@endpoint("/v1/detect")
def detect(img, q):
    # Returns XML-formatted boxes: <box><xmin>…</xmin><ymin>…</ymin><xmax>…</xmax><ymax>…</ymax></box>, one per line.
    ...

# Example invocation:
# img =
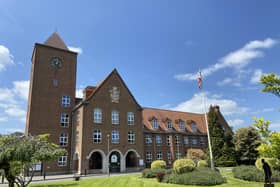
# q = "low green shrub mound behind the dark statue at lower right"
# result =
<box><xmin>232</xmin><ymin>166</ymin><xmax>280</xmax><ymax>182</ymax></box>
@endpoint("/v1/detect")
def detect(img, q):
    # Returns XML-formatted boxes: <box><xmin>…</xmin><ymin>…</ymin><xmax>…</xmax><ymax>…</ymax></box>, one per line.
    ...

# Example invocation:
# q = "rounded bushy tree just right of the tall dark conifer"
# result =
<box><xmin>234</xmin><ymin>127</ymin><xmax>261</xmax><ymax>165</ymax></box>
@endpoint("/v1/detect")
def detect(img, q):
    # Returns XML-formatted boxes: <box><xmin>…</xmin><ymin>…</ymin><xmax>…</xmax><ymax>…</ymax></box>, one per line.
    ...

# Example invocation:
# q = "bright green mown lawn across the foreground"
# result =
<box><xmin>31</xmin><ymin>168</ymin><xmax>280</xmax><ymax>187</ymax></box>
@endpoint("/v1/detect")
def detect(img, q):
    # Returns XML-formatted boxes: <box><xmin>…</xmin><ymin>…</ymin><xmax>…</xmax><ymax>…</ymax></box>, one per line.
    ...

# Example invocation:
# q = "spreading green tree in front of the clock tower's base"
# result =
<box><xmin>0</xmin><ymin>135</ymin><xmax>65</xmax><ymax>187</ymax></box>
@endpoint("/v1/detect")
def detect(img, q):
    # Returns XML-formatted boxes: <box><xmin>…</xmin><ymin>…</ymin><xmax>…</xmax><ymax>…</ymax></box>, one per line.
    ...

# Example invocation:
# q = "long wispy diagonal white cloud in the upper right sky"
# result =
<box><xmin>175</xmin><ymin>38</ymin><xmax>278</xmax><ymax>80</ymax></box>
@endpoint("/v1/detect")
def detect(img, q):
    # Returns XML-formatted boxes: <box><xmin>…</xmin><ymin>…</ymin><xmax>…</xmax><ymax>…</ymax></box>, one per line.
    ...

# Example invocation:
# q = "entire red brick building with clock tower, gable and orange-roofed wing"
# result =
<box><xmin>25</xmin><ymin>33</ymin><xmax>229</xmax><ymax>173</ymax></box>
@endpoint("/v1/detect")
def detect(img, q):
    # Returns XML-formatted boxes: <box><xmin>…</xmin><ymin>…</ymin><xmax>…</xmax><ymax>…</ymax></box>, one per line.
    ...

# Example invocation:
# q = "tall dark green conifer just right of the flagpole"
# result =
<box><xmin>207</xmin><ymin>107</ymin><xmax>236</xmax><ymax>166</ymax></box>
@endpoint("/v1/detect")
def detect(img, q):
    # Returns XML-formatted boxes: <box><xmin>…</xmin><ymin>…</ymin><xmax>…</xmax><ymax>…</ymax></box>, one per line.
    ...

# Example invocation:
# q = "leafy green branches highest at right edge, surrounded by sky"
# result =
<box><xmin>260</xmin><ymin>73</ymin><xmax>280</xmax><ymax>97</ymax></box>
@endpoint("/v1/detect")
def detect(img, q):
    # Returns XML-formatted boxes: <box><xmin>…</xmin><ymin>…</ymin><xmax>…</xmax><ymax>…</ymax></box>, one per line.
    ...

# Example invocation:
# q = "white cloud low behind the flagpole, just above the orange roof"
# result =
<box><xmin>171</xmin><ymin>93</ymin><xmax>248</xmax><ymax>115</ymax></box>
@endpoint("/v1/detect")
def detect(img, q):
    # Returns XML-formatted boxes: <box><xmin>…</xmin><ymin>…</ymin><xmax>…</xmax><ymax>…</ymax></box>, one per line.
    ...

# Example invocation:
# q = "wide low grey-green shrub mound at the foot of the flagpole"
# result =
<box><xmin>164</xmin><ymin>168</ymin><xmax>226</xmax><ymax>185</ymax></box>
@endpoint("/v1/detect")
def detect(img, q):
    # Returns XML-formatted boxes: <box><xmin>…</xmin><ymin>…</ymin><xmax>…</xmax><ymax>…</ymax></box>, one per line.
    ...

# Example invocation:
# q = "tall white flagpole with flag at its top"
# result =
<box><xmin>198</xmin><ymin>70</ymin><xmax>215</xmax><ymax>170</ymax></box>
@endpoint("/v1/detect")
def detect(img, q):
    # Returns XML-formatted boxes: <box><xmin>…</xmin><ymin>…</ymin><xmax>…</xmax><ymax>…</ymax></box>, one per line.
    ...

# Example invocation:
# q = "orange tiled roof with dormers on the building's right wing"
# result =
<box><xmin>142</xmin><ymin>108</ymin><xmax>206</xmax><ymax>134</ymax></box>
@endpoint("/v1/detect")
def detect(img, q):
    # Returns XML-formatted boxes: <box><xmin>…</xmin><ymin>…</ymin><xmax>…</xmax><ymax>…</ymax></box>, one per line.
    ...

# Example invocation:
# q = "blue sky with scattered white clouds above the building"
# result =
<box><xmin>0</xmin><ymin>0</ymin><xmax>280</xmax><ymax>134</ymax></box>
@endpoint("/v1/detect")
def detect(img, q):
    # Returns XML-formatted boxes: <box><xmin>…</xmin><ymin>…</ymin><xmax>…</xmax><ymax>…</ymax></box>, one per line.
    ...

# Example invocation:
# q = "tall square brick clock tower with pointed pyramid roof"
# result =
<box><xmin>25</xmin><ymin>32</ymin><xmax>77</xmax><ymax>173</ymax></box>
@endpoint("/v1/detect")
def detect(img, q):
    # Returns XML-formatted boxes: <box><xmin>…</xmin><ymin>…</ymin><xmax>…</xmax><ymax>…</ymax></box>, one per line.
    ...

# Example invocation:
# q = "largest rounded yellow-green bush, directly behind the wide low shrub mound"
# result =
<box><xmin>173</xmin><ymin>159</ymin><xmax>195</xmax><ymax>174</ymax></box>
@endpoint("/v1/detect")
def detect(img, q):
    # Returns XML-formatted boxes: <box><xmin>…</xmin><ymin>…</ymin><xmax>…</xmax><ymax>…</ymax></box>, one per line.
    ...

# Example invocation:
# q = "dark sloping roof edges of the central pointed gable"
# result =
<box><xmin>84</xmin><ymin>69</ymin><xmax>142</xmax><ymax>108</ymax></box>
